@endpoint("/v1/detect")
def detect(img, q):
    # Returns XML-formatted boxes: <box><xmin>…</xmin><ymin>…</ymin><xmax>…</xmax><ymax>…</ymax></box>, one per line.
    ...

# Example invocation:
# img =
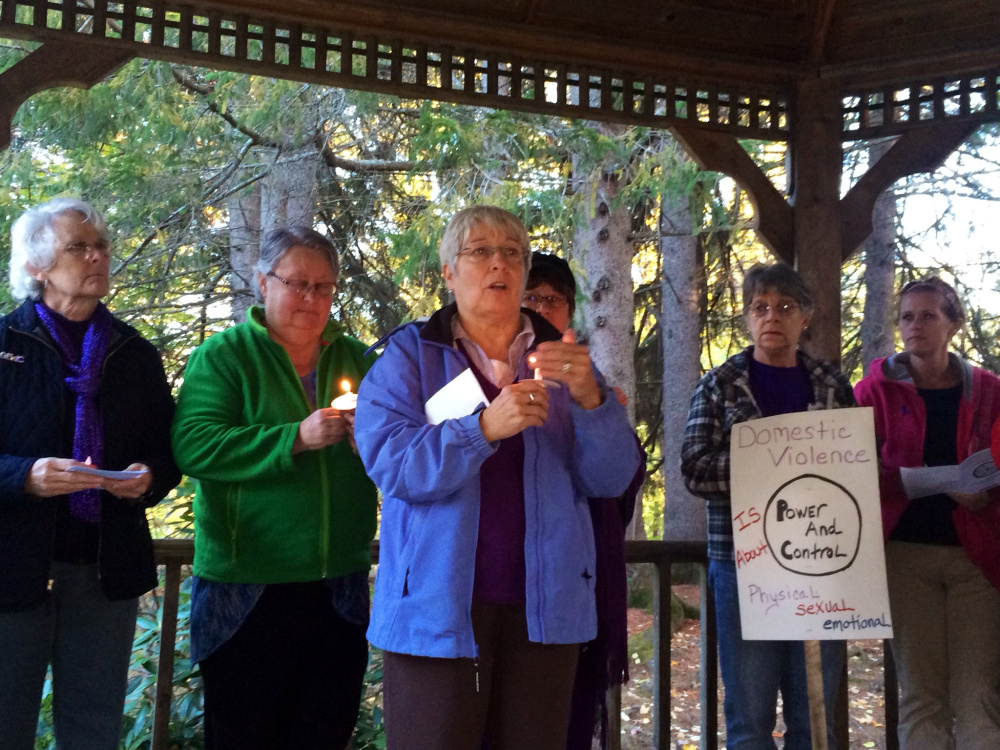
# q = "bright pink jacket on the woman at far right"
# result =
<box><xmin>854</xmin><ymin>352</ymin><xmax>1000</xmax><ymax>589</ymax></box>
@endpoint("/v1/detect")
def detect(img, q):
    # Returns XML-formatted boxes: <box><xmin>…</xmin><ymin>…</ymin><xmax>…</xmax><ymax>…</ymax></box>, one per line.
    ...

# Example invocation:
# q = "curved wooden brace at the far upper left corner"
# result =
<box><xmin>0</xmin><ymin>39</ymin><xmax>134</xmax><ymax>149</ymax></box>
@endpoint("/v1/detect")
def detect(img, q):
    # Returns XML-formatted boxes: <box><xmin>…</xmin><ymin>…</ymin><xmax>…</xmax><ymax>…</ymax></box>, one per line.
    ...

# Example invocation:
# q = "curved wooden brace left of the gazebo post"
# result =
<box><xmin>670</xmin><ymin>125</ymin><xmax>795</xmax><ymax>264</ymax></box>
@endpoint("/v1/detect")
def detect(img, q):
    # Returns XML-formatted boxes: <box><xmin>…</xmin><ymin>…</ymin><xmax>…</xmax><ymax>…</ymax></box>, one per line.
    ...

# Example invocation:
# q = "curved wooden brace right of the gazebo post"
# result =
<box><xmin>840</xmin><ymin>122</ymin><xmax>976</xmax><ymax>260</ymax></box>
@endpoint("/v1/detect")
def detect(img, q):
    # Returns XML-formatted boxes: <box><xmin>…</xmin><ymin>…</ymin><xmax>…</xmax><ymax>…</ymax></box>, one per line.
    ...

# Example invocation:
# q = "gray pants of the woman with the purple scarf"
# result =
<box><xmin>0</xmin><ymin>563</ymin><xmax>138</xmax><ymax>750</ymax></box>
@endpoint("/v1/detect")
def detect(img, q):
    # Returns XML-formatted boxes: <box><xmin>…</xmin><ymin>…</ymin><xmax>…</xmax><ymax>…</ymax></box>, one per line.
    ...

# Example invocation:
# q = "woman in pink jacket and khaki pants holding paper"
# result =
<box><xmin>855</xmin><ymin>277</ymin><xmax>1000</xmax><ymax>750</ymax></box>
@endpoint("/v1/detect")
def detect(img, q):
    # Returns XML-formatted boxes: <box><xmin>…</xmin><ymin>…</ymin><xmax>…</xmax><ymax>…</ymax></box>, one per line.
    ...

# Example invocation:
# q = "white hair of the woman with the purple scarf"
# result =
<box><xmin>10</xmin><ymin>198</ymin><xmax>111</xmax><ymax>302</ymax></box>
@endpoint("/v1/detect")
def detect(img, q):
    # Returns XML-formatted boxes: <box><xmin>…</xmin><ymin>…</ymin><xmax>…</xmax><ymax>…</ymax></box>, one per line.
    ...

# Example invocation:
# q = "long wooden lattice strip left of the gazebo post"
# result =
<box><xmin>0</xmin><ymin>0</ymin><xmax>789</xmax><ymax>140</ymax></box>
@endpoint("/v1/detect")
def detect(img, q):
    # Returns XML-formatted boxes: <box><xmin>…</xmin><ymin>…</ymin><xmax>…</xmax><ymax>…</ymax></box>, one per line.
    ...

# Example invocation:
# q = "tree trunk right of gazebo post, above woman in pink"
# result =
<box><xmin>861</xmin><ymin>140</ymin><xmax>897</xmax><ymax>375</ymax></box>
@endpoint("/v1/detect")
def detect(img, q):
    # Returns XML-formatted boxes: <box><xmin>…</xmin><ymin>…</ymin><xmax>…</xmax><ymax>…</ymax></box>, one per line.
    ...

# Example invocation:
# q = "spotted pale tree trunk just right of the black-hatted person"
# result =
<box><xmin>574</xmin><ymin>124</ymin><xmax>645</xmax><ymax>538</ymax></box>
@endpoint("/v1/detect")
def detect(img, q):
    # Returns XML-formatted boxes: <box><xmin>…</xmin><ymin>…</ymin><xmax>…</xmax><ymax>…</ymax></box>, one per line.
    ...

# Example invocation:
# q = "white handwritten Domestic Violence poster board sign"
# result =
<box><xmin>730</xmin><ymin>407</ymin><xmax>892</xmax><ymax>641</ymax></box>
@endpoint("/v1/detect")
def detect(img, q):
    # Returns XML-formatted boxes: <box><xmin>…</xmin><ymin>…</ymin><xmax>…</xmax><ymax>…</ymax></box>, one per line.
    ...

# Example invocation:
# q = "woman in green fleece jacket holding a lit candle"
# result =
<box><xmin>173</xmin><ymin>227</ymin><xmax>376</xmax><ymax>750</ymax></box>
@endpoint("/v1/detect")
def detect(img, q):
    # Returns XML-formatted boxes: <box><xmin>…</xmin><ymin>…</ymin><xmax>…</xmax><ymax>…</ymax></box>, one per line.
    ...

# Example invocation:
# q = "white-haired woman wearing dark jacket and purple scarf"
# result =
<box><xmin>0</xmin><ymin>198</ymin><xmax>180</xmax><ymax>750</ymax></box>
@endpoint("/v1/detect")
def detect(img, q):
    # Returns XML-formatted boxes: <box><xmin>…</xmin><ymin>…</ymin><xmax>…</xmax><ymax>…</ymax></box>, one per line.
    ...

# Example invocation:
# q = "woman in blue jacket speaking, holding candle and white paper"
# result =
<box><xmin>355</xmin><ymin>206</ymin><xmax>639</xmax><ymax>750</ymax></box>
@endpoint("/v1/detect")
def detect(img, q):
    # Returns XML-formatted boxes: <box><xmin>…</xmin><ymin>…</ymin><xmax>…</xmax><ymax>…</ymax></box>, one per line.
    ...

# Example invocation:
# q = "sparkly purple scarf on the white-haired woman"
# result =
<box><xmin>35</xmin><ymin>302</ymin><xmax>111</xmax><ymax>524</ymax></box>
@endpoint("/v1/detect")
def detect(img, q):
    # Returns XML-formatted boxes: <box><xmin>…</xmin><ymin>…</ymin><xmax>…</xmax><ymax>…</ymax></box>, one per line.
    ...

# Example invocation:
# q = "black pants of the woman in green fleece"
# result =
<box><xmin>201</xmin><ymin>581</ymin><xmax>368</xmax><ymax>750</ymax></box>
